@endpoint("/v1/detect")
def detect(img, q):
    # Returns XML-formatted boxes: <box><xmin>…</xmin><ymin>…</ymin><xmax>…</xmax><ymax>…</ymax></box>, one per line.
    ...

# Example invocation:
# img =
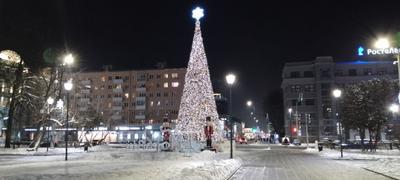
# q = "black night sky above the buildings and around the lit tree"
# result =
<box><xmin>0</xmin><ymin>0</ymin><xmax>400</xmax><ymax>129</ymax></box>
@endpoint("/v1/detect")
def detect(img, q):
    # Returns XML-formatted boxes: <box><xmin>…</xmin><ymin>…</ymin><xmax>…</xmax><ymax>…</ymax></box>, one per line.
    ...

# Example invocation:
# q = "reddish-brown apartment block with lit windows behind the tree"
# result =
<box><xmin>70</xmin><ymin>68</ymin><xmax>186</xmax><ymax>128</ymax></box>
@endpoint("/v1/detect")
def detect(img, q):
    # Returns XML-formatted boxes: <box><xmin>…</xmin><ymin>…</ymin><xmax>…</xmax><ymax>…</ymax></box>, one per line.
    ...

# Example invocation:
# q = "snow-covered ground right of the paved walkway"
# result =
<box><xmin>304</xmin><ymin>148</ymin><xmax>400</xmax><ymax>179</ymax></box>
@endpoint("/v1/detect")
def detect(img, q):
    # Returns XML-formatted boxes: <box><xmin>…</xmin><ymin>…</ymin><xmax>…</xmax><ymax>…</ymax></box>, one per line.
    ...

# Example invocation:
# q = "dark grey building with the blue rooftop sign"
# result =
<box><xmin>281</xmin><ymin>57</ymin><xmax>398</xmax><ymax>142</ymax></box>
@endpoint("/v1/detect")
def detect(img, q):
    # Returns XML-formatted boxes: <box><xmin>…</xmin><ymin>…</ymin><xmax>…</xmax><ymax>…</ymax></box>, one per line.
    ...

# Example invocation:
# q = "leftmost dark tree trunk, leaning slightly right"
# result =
<box><xmin>4</xmin><ymin>60</ymin><xmax>24</xmax><ymax>148</ymax></box>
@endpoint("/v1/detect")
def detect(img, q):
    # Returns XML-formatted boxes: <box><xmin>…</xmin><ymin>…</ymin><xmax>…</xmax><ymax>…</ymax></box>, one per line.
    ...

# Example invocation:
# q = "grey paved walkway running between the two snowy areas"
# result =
<box><xmin>231</xmin><ymin>145</ymin><xmax>388</xmax><ymax>180</ymax></box>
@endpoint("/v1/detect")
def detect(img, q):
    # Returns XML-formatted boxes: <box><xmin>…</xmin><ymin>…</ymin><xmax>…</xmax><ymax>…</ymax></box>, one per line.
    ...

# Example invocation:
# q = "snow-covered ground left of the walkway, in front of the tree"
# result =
<box><xmin>0</xmin><ymin>145</ymin><xmax>241</xmax><ymax>180</ymax></box>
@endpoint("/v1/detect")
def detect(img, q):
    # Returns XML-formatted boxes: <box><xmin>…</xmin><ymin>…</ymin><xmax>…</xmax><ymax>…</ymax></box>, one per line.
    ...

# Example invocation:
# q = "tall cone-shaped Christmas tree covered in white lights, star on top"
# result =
<box><xmin>176</xmin><ymin>8</ymin><xmax>222</xmax><ymax>140</ymax></box>
